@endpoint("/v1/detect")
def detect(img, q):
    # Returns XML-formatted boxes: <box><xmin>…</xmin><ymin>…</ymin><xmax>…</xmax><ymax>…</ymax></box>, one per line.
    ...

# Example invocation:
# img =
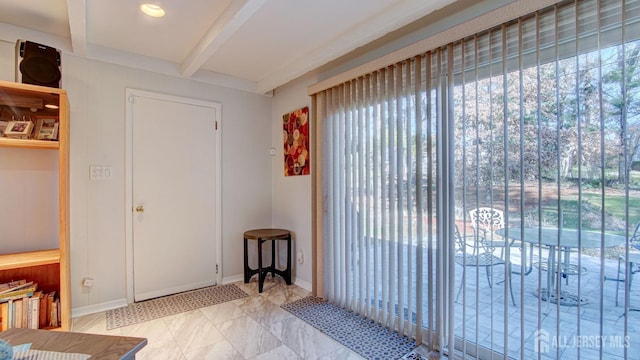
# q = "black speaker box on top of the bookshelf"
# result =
<box><xmin>16</xmin><ymin>40</ymin><xmax>62</xmax><ymax>88</ymax></box>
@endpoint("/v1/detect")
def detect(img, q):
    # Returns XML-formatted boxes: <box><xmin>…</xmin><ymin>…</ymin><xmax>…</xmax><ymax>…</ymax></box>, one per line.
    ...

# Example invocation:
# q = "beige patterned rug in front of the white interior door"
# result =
<box><xmin>106</xmin><ymin>284</ymin><xmax>249</xmax><ymax>330</ymax></box>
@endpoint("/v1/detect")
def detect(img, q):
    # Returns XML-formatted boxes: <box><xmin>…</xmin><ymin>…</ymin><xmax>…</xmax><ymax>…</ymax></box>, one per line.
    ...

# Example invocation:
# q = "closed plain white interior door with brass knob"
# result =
<box><xmin>129</xmin><ymin>93</ymin><xmax>220</xmax><ymax>301</ymax></box>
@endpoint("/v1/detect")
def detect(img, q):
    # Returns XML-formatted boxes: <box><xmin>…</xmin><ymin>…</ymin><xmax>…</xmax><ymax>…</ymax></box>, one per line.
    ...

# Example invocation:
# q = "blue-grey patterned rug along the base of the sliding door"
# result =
<box><xmin>281</xmin><ymin>296</ymin><xmax>416</xmax><ymax>359</ymax></box>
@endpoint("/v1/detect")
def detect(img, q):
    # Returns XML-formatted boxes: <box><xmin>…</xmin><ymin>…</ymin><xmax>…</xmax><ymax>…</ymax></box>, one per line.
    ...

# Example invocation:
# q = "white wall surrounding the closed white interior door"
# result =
<box><xmin>0</xmin><ymin>35</ymin><xmax>273</xmax><ymax>316</ymax></box>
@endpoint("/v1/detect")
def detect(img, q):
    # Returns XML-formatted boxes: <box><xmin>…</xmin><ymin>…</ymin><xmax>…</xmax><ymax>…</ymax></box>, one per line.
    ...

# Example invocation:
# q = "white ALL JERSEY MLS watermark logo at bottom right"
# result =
<box><xmin>534</xmin><ymin>329</ymin><xmax>630</xmax><ymax>354</ymax></box>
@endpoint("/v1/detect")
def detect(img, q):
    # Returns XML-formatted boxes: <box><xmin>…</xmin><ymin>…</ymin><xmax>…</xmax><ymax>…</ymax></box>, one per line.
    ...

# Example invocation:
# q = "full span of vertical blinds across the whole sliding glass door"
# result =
<box><xmin>314</xmin><ymin>0</ymin><xmax>640</xmax><ymax>359</ymax></box>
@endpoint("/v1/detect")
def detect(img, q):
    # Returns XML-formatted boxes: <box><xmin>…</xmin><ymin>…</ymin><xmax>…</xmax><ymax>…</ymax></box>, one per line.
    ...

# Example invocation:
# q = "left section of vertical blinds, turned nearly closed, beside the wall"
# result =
<box><xmin>315</xmin><ymin>49</ymin><xmax>453</xmax><ymax>354</ymax></box>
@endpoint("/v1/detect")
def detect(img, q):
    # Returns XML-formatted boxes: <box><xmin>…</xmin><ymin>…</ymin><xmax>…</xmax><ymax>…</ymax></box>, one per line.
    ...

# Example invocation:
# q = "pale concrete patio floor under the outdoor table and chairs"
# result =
<box><xmin>455</xmin><ymin>243</ymin><xmax>640</xmax><ymax>359</ymax></box>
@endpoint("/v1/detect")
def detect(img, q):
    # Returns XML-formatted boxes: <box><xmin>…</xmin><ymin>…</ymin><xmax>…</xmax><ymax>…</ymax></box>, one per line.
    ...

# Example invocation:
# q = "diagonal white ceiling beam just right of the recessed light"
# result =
<box><xmin>180</xmin><ymin>0</ymin><xmax>266</xmax><ymax>77</ymax></box>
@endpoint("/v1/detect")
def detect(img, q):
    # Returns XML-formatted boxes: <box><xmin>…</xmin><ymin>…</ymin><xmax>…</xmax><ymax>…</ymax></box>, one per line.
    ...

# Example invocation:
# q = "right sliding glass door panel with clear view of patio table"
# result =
<box><xmin>452</xmin><ymin>1</ymin><xmax>640</xmax><ymax>359</ymax></box>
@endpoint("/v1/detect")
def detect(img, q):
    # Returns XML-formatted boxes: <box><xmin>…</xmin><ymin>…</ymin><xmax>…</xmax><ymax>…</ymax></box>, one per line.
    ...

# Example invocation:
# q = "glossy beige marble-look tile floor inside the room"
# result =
<box><xmin>72</xmin><ymin>278</ymin><xmax>410</xmax><ymax>360</ymax></box>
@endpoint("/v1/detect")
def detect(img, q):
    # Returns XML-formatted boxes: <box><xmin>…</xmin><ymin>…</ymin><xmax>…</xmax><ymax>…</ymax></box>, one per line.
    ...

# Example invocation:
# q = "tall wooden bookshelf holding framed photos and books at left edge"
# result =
<box><xmin>0</xmin><ymin>81</ymin><xmax>71</xmax><ymax>331</ymax></box>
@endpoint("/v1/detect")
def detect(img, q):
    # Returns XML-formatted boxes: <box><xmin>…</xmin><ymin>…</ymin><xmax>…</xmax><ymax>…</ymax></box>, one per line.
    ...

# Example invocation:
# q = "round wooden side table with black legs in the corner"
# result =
<box><xmin>244</xmin><ymin>229</ymin><xmax>291</xmax><ymax>293</ymax></box>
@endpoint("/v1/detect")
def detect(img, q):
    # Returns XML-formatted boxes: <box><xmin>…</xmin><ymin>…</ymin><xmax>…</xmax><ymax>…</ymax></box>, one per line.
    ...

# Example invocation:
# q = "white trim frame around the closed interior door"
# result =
<box><xmin>125</xmin><ymin>88</ymin><xmax>222</xmax><ymax>304</ymax></box>
